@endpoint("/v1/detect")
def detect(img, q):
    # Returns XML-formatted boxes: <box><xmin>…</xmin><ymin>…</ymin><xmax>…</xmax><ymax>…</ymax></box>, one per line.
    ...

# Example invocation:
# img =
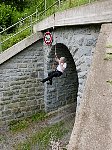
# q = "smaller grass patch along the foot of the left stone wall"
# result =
<box><xmin>9</xmin><ymin>112</ymin><xmax>48</xmax><ymax>133</ymax></box>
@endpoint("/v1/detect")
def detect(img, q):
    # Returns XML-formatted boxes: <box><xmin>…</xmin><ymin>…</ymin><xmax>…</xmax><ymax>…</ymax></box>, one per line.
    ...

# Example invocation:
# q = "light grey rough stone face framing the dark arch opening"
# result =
<box><xmin>44</xmin><ymin>24</ymin><xmax>101</xmax><ymax>111</ymax></box>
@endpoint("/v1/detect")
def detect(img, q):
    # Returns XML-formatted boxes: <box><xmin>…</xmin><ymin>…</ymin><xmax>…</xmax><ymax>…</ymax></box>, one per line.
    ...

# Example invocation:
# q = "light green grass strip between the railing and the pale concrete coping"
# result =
<box><xmin>0</xmin><ymin>0</ymin><xmax>96</xmax><ymax>53</ymax></box>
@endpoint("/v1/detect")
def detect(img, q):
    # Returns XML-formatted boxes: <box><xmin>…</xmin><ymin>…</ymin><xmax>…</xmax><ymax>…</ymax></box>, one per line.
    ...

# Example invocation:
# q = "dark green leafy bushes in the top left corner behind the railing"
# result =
<box><xmin>0</xmin><ymin>0</ymin><xmax>55</xmax><ymax>31</ymax></box>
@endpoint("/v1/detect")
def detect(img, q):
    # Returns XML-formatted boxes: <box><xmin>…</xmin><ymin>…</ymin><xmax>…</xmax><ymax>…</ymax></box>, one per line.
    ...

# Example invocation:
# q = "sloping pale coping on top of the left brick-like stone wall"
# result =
<box><xmin>0</xmin><ymin>32</ymin><xmax>43</xmax><ymax>64</ymax></box>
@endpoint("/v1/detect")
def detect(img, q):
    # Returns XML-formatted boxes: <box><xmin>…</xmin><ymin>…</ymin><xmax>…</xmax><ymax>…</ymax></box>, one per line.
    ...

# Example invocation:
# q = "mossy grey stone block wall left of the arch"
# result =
<box><xmin>0</xmin><ymin>40</ymin><xmax>44</xmax><ymax>122</ymax></box>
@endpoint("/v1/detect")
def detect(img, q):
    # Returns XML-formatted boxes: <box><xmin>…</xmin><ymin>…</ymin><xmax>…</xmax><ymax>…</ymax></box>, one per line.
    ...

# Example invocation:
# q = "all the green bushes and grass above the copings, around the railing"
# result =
<box><xmin>0</xmin><ymin>0</ymin><xmax>96</xmax><ymax>52</ymax></box>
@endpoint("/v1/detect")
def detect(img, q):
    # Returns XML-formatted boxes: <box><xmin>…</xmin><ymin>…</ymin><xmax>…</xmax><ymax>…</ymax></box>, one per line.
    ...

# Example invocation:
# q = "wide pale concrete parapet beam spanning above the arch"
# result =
<box><xmin>33</xmin><ymin>0</ymin><xmax>112</xmax><ymax>32</ymax></box>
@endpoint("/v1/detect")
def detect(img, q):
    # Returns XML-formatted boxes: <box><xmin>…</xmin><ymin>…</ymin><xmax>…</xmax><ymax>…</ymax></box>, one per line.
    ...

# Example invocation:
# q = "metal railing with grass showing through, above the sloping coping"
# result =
<box><xmin>0</xmin><ymin>0</ymin><xmax>96</xmax><ymax>53</ymax></box>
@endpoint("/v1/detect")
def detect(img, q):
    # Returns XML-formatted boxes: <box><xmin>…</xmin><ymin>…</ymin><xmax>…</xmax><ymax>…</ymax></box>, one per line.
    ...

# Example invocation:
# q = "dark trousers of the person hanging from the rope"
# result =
<box><xmin>42</xmin><ymin>70</ymin><xmax>62</xmax><ymax>85</ymax></box>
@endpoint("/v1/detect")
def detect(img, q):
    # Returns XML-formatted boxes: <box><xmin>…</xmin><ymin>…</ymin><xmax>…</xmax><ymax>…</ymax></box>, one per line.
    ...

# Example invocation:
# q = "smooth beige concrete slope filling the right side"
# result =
<box><xmin>68</xmin><ymin>24</ymin><xmax>112</xmax><ymax>150</ymax></box>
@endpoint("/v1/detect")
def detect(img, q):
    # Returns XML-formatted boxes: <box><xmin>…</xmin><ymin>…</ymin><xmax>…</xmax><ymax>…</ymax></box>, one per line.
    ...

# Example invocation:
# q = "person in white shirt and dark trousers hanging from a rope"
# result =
<box><xmin>41</xmin><ymin>53</ymin><xmax>67</xmax><ymax>85</ymax></box>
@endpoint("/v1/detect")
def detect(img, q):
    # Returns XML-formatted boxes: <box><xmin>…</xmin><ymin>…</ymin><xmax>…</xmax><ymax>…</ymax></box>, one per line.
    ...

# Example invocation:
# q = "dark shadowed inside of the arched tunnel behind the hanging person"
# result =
<box><xmin>46</xmin><ymin>43</ymin><xmax>78</xmax><ymax>112</ymax></box>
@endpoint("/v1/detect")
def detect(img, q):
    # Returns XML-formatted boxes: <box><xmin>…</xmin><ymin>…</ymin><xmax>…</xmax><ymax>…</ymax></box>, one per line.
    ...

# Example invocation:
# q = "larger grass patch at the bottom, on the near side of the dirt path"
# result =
<box><xmin>15</xmin><ymin>122</ymin><xmax>68</xmax><ymax>150</ymax></box>
